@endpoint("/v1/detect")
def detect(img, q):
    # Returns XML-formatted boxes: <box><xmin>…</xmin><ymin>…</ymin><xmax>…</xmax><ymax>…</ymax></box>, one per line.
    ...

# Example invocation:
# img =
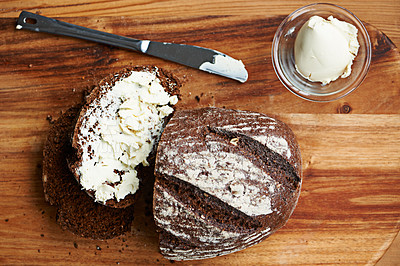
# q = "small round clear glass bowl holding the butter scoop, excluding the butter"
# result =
<box><xmin>272</xmin><ymin>3</ymin><xmax>371</xmax><ymax>102</ymax></box>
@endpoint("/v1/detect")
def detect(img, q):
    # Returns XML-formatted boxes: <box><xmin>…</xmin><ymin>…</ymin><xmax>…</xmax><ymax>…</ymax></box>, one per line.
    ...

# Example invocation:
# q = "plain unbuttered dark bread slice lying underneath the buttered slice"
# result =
<box><xmin>42</xmin><ymin>105</ymin><xmax>133</xmax><ymax>239</ymax></box>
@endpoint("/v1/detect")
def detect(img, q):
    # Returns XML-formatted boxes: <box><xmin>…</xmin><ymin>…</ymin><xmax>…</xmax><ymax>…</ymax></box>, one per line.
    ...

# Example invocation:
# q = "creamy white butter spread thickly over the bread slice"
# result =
<box><xmin>78</xmin><ymin>72</ymin><xmax>178</xmax><ymax>203</ymax></box>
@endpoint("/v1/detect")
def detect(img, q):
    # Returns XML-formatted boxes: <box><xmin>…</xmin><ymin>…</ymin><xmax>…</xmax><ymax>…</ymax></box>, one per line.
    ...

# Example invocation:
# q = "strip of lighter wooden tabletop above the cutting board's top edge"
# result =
<box><xmin>0</xmin><ymin>0</ymin><xmax>400</xmax><ymax>47</ymax></box>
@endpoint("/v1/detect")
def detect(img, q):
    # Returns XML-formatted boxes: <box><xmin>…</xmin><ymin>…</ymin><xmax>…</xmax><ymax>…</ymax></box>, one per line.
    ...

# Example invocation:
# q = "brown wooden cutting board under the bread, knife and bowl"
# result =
<box><xmin>0</xmin><ymin>16</ymin><xmax>400</xmax><ymax>265</ymax></box>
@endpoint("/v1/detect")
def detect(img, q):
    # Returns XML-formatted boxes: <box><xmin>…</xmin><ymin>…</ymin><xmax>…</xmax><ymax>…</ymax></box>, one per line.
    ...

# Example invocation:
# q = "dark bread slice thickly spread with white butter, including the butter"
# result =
<box><xmin>68</xmin><ymin>67</ymin><xmax>180</xmax><ymax>208</ymax></box>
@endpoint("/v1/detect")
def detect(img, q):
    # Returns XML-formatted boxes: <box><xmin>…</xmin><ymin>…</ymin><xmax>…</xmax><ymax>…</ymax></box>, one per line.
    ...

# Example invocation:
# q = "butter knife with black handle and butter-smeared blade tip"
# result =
<box><xmin>16</xmin><ymin>11</ymin><xmax>248</xmax><ymax>82</ymax></box>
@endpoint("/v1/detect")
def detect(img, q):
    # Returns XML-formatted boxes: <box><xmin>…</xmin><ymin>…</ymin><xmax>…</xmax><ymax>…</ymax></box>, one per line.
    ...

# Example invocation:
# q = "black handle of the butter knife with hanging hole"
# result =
<box><xmin>17</xmin><ymin>11</ymin><xmax>142</xmax><ymax>52</ymax></box>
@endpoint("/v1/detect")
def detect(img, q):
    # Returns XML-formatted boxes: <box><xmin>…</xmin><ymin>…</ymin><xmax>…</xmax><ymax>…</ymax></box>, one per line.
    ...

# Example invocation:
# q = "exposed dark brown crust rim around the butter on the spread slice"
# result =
<box><xmin>68</xmin><ymin>66</ymin><xmax>181</xmax><ymax>208</ymax></box>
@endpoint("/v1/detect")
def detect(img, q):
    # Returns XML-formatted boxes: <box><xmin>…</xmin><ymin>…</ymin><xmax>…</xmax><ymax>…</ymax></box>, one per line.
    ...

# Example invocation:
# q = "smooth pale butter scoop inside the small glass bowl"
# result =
<box><xmin>294</xmin><ymin>16</ymin><xmax>360</xmax><ymax>85</ymax></box>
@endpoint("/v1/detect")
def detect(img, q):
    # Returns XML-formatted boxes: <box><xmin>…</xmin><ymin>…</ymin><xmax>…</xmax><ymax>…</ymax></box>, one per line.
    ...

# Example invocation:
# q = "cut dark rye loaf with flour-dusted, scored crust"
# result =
<box><xmin>153</xmin><ymin>108</ymin><xmax>302</xmax><ymax>260</ymax></box>
